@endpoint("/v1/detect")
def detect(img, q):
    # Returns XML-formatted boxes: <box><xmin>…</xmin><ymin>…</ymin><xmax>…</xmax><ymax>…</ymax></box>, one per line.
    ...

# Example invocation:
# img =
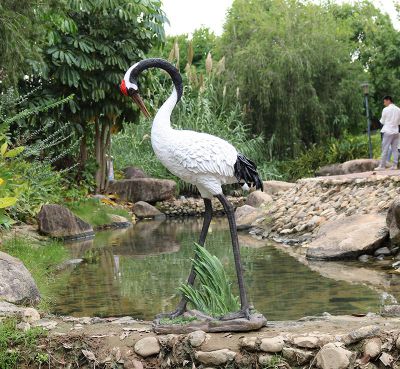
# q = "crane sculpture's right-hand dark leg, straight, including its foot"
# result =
<box><xmin>217</xmin><ymin>194</ymin><xmax>250</xmax><ymax>320</ymax></box>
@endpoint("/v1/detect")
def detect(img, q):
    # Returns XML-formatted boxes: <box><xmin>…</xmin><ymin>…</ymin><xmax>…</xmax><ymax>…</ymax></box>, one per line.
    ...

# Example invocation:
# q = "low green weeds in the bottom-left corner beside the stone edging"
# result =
<box><xmin>0</xmin><ymin>318</ymin><xmax>48</xmax><ymax>369</ymax></box>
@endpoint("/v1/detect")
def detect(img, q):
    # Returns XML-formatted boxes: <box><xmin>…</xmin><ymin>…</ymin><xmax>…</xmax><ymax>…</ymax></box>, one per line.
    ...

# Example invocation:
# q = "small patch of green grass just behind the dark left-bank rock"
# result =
<box><xmin>66</xmin><ymin>198</ymin><xmax>131</xmax><ymax>227</ymax></box>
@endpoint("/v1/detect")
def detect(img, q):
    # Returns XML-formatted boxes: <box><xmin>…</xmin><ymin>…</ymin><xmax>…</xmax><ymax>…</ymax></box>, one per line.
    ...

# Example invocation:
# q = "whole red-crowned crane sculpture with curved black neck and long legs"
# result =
<box><xmin>120</xmin><ymin>58</ymin><xmax>263</xmax><ymax>319</ymax></box>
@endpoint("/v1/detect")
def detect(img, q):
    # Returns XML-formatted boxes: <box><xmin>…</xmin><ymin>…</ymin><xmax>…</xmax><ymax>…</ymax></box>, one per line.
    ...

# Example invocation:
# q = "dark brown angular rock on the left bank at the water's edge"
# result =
<box><xmin>37</xmin><ymin>205</ymin><xmax>94</xmax><ymax>238</ymax></box>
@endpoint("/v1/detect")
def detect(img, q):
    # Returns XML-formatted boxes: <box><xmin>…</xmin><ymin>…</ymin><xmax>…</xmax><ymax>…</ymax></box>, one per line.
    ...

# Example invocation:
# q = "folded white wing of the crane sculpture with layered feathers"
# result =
<box><xmin>171</xmin><ymin>131</ymin><xmax>237</xmax><ymax>177</ymax></box>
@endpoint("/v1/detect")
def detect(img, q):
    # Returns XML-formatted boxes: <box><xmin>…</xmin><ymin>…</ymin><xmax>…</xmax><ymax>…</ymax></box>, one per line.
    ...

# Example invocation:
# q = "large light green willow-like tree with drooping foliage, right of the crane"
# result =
<box><xmin>221</xmin><ymin>0</ymin><xmax>365</xmax><ymax>158</ymax></box>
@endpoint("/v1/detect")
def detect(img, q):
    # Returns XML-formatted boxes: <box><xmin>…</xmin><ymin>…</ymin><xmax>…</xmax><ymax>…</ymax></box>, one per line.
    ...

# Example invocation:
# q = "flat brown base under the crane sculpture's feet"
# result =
<box><xmin>153</xmin><ymin>310</ymin><xmax>267</xmax><ymax>334</ymax></box>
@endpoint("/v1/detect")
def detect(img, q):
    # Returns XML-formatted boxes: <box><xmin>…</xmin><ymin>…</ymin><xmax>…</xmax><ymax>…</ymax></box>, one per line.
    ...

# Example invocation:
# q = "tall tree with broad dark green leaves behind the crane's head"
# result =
<box><xmin>36</xmin><ymin>0</ymin><xmax>166</xmax><ymax>191</ymax></box>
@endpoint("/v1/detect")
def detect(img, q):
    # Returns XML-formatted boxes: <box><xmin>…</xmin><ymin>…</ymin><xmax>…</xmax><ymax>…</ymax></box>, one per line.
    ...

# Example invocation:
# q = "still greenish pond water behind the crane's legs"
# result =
<box><xmin>53</xmin><ymin>218</ymin><xmax>398</xmax><ymax>320</ymax></box>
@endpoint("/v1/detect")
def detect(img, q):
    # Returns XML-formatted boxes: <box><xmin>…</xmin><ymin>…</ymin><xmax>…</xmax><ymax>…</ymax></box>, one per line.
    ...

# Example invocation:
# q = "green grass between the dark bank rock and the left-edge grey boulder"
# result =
<box><xmin>0</xmin><ymin>237</ymin><xmax>69</xmax><ymax>310</ymax></box>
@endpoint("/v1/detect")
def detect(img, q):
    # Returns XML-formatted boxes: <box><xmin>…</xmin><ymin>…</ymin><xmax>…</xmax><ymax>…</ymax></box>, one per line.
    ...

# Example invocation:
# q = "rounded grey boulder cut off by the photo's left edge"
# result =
<box><xmin>0</xmin><ymin>251</ymin><xmax>40</xmax><ymax>305</ymax></box>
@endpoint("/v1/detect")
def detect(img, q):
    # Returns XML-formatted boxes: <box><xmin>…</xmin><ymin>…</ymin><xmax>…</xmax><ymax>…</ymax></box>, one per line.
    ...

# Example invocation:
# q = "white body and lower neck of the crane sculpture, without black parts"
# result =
<box><xmin>151</xmin><ymin>89</ymin><xmax>237</xmax><ymax>198</ymax></box>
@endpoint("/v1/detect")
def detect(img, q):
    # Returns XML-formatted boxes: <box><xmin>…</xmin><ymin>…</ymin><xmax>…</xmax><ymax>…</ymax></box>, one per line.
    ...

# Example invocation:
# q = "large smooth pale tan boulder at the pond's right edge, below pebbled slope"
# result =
<box><xmin>307</xmin><ymin>214</ymin><xmax>388</xmax><ymax>260</ymax></box>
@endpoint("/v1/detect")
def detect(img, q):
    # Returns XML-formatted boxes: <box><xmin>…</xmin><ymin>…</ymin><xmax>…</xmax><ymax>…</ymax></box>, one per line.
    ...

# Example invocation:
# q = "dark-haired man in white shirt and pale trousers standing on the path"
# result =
<box><xmin>375</xmin><ymin>96</ymin><xmax>400</xmax><ymax>170</ymax></box>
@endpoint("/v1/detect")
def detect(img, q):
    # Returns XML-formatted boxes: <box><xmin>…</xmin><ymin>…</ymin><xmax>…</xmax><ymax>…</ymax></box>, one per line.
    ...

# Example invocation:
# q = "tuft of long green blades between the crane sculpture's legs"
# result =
<box><xmin>179</xmin><ymin>244</ymin><xmax>239</xmax><ymax>317</ymax></box>
